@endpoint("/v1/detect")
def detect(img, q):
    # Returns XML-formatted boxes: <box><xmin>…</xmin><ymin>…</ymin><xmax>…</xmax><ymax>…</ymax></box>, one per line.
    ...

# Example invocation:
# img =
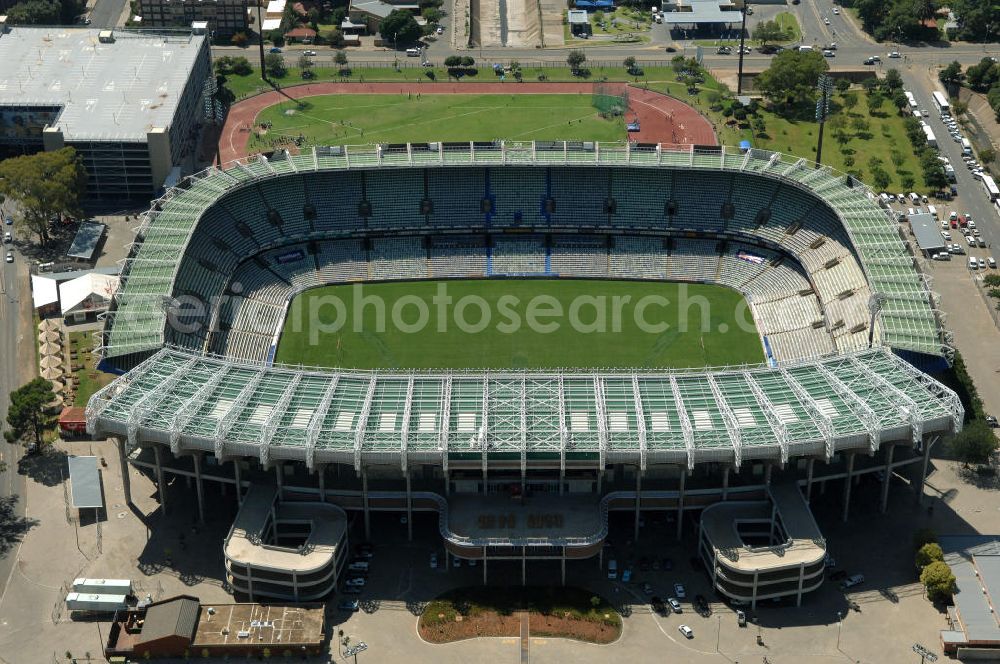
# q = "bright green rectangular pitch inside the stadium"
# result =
<box><xmin>275</xmin><ymin>279</ymin><xmax>763</xmax><ymax>369</ymax></box>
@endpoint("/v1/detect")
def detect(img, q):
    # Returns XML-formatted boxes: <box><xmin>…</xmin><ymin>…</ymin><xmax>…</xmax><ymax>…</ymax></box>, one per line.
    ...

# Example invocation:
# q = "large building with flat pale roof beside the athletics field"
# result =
<box><xmin>0</xmin><ymin>26</ymin><xmax>212</xmax><ymax>199</ymax></box>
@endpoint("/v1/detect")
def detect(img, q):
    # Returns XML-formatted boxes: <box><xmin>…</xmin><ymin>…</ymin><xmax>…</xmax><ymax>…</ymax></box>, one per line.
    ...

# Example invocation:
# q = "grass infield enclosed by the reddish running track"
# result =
<box><xmin>250</xmin><ymin>94</ymin><xmax>626</xmax><ymax>148</ymax></box>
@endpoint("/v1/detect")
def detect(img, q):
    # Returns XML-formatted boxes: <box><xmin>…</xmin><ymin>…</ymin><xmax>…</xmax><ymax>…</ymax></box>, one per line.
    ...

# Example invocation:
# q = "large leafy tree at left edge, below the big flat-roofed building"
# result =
<box><xmin>0</xmin><ymin>148</ymin><xmax>87</xmax><ymax>245</ymax></box>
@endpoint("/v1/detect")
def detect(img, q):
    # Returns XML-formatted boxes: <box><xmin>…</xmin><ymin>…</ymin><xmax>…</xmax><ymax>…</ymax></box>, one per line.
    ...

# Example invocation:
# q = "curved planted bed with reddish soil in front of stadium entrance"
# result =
<box><xmin>418</xmin><ymin>586</ymin><xmax>622</xmax><ymax>643</ymax></box>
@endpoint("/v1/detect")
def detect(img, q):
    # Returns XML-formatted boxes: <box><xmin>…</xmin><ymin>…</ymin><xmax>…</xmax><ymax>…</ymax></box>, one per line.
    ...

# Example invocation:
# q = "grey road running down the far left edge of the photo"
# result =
<box><xmin>0</xmin><ymin>209</ymin><xmax>34</xmax><ymax>608</ymax></box>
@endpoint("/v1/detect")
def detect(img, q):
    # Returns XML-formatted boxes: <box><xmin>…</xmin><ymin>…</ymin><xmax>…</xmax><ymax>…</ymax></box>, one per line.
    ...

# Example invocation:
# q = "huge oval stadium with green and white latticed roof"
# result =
<box><xmin>87</xmin><ymin>142</ymin><xmax>964</xmax><ymax>603</ymax></box>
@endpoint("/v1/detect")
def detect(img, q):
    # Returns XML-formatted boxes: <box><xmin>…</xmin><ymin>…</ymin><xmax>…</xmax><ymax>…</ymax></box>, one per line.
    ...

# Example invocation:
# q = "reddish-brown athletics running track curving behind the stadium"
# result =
<box><xmin>219</xmin><ymin>83</ymin><xmax>717</xmax><ymax>164</ymax></box>
